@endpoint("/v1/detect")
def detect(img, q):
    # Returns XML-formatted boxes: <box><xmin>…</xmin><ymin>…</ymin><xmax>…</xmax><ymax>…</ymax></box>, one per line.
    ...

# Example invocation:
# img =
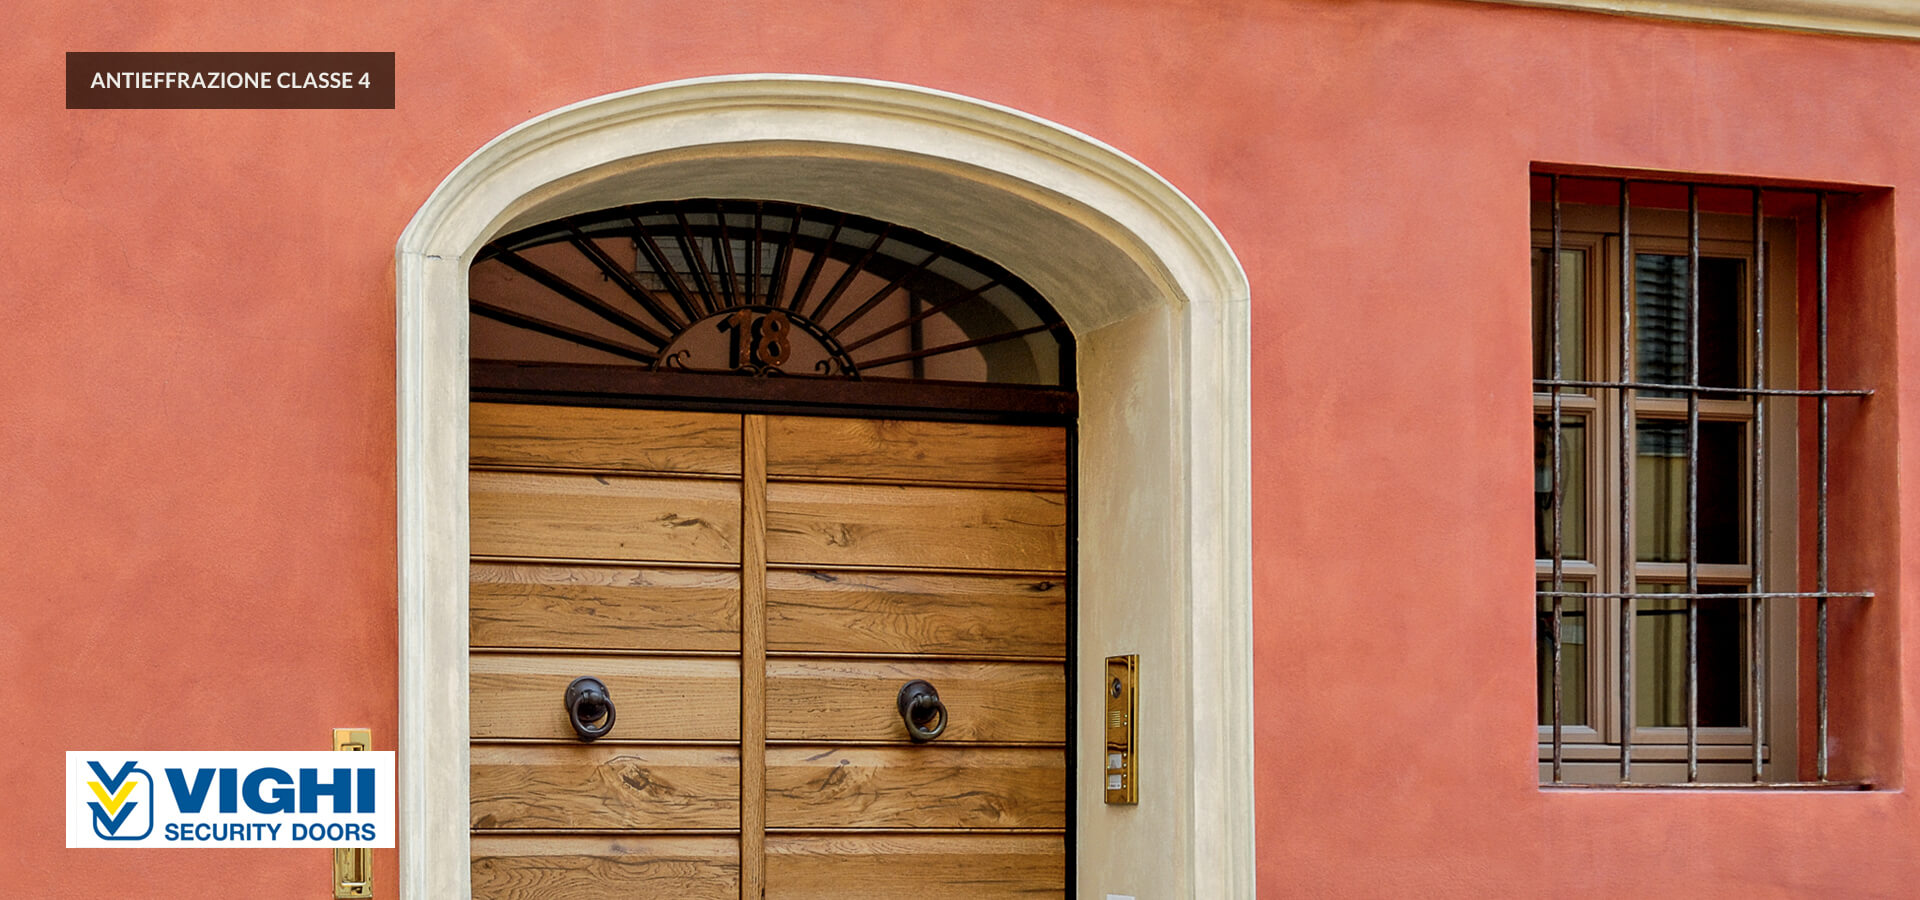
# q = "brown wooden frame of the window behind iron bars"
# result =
<box><xmin>1530</xmin><ymin>203</ymin><xmax>1799</xmax><ymax>785</ymax></box>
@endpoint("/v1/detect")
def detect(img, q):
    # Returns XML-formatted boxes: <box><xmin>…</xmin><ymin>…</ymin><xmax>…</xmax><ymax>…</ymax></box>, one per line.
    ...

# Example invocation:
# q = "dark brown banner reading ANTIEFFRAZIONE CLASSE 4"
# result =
<box><xmin>67</xmin><ymin>52</ymin><xmax>394</xmax><ymax>109</ymax></box>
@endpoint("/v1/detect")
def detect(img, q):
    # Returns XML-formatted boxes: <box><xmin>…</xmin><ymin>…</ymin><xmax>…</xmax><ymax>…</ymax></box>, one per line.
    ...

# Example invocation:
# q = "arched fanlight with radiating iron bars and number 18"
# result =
<box><xmin>470</xmin><ymin>200</ymin><xmax>1073</xmax><ymax>388</ymax></box>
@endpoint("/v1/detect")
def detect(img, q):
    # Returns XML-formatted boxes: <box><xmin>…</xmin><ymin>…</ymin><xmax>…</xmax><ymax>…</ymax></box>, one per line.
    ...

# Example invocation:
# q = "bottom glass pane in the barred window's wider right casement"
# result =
<box><xmin>1628</xmin><ymin>583</ymin><xmax>1747</xmax><ymax>727</ymax></box>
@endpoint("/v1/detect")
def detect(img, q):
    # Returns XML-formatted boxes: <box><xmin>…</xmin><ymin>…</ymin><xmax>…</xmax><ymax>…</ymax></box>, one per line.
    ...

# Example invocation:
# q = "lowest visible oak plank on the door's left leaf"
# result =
<box><xmin>472</xmin><ymin>835</ymin><xmax>739</xmax><ymax>900</ymax></box>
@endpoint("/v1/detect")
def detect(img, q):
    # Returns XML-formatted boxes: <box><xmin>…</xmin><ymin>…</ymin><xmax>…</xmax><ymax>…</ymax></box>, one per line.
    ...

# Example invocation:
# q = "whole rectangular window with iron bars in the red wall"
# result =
<box><xmin>1532</xmin><ymin>175</ymin><xmax>1872</xmax><ymax>787</ymax></box>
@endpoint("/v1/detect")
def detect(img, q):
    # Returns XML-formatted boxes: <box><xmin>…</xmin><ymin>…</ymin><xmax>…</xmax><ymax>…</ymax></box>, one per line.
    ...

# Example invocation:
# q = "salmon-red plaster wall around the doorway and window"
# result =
<box><xmin>0</xmin><ymin>0</ymin><xmax>1920</xmax><ymax>898</ymax></box>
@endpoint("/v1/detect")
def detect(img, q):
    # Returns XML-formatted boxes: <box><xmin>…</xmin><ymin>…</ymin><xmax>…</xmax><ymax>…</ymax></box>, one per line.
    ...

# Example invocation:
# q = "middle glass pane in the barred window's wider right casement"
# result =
<box><xmin>1635</xmin><ymin>418</ymin><xmax>1747</xmax><ymax>562</ymax></box>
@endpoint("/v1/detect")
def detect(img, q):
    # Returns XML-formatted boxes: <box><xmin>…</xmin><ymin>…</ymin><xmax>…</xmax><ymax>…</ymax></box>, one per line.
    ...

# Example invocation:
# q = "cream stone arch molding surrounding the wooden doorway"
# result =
<box><xmin>396</xmin><ymin>75</ymin><xmax>1254</xmax><ymax>898</ymax></box>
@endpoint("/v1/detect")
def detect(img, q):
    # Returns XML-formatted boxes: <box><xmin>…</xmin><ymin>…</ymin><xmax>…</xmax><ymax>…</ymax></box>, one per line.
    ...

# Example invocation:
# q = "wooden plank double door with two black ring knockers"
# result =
<box><xmin>468</xmin><ymin>403</ymin><xmax>1071</xmax><ymax>900</ymax></box>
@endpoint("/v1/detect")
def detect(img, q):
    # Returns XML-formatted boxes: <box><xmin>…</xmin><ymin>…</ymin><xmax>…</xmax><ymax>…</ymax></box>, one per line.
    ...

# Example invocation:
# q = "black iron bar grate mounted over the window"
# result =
<box><xmin>1534</xmin><ymin>175</ymin><xmax>1872</xmax><ymax>789</ymax></box>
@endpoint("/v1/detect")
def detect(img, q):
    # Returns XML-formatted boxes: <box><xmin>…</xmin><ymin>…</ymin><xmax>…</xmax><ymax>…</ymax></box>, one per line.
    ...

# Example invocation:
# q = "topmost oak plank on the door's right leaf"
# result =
<box><xmin>766</xmin><ymin>416</ymin><xmax>1068</xmax><ymax>489</ymax></box>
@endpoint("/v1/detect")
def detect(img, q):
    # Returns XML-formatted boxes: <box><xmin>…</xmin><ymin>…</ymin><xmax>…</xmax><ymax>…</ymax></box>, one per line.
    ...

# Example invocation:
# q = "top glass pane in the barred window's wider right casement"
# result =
<box><xmin>1634</xmin><ymin>253</ymin><xmax>1747</xmax><ymax>397</ymax></box>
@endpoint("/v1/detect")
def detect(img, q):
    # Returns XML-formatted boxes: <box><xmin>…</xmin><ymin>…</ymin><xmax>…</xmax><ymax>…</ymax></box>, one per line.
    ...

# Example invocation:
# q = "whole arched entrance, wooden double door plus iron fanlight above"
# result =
<box><xmin>468</xmin><ymin>200</ymin><xmax>1073</xmax><ymax>900</ymax></box>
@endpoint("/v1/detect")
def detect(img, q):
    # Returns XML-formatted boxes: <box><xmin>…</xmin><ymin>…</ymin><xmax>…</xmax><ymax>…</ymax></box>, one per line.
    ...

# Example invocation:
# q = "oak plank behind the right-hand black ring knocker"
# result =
<box><xmin>766</xmin><ymin>658</ymin><xmax>1066</xmax><ymax>745</ymax></box>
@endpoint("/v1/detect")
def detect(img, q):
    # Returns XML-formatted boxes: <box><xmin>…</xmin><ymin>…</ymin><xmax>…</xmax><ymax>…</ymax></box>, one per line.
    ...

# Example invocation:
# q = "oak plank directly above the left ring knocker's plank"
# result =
<box><xmin>467</xmin><ymin>562</ymin><xmax>739</xmax><ymax>652</ymax></box>
